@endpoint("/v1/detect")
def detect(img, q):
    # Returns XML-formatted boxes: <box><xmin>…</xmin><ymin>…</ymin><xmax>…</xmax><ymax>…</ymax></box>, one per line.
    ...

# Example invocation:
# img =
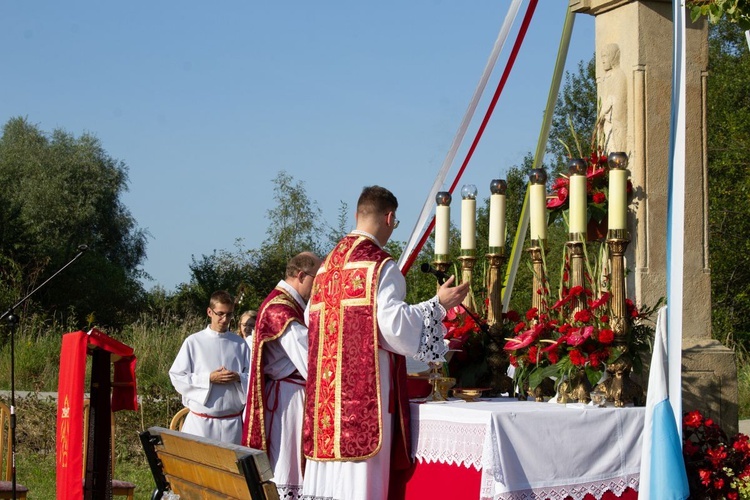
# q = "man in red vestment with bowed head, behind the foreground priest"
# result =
<box><xmin>242</xmin><ymin>252</ymin><xmax>320</xmax><ymax>499</ymax></box>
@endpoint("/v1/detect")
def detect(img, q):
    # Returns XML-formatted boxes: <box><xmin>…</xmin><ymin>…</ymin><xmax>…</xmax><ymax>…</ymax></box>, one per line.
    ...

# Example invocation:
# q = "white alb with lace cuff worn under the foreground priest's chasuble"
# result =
<box><xmin>302</xmin><ymin>231</ymin><xmax>447</xmax><ymax>500</ymax></box>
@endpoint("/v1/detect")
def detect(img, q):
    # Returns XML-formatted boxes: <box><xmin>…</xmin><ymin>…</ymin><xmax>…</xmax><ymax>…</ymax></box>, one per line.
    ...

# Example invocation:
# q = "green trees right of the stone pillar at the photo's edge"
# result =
<box><xmin>707</xmin><ymin>19</ymin><xmax>750</xmax><ymax>350</ymax></box>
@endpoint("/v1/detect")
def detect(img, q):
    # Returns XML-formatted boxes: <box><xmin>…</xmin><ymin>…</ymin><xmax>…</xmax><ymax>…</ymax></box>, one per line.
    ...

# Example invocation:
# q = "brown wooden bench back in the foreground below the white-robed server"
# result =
<box><xmin>141</xmin><ymin>427</ymin><xmax>279</xmax><ymax>500</ymax></box>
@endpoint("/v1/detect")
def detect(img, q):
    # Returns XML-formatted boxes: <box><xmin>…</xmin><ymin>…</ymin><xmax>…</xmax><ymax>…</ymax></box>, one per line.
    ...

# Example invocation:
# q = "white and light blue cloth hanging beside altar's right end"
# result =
<box><xmin>638</xmin><ymin>306</ymin><xmax>690</xmax><ymax>500</ymax></box>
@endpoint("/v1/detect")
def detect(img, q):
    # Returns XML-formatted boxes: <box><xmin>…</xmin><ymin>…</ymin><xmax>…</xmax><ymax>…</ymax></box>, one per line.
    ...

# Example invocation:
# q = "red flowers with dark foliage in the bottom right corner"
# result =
<box><xmin>682</xmin><ymin>410</ymin><xmax>750</xmax><ymax>500</ymax></box>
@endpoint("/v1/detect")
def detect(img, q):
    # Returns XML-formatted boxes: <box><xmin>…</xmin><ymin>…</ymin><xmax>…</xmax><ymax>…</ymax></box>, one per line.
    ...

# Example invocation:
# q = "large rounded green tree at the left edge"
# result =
<box><xmin>0</xmin><ymin>118</ymin><xmax>147</xmax><ymax>326</ymax></box>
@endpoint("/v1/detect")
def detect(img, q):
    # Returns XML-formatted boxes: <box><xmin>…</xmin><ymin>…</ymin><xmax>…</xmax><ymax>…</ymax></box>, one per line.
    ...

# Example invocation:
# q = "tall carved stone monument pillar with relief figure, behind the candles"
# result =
<box><xmin>570</xmin><ymin>0</ymin><xmax>738</xmax><ymax>433</ymax></box>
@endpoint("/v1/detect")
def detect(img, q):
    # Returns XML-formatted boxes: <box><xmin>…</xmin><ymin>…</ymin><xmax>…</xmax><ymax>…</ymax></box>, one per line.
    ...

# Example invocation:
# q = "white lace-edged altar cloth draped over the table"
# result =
<box><xmin>411</xmin><ymin>398</ymin><xmax>645</xmax><ymax>500</ymax></box>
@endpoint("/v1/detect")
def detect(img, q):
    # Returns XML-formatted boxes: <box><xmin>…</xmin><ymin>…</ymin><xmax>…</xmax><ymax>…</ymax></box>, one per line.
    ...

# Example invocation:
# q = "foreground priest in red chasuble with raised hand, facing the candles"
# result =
<box><xmin>303</xmin><ymin>186</ymin><xmax>469</xmax><ymax>500</ymax></box>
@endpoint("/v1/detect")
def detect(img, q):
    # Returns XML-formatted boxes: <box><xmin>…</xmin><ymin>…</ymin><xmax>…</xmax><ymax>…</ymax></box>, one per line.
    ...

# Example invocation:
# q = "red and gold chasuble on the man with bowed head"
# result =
<box><xmin>242</xmin><ymin>287</ymin><xmax>305</xmax><ymax>451</ymax></box>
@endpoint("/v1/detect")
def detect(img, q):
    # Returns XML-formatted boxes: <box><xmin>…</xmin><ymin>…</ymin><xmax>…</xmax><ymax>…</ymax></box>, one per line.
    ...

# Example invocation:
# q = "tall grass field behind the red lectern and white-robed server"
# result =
<box><xmin>0</xmin><ymin>314</ymin><xmax>750</xmax><ymax>500</ymax></box>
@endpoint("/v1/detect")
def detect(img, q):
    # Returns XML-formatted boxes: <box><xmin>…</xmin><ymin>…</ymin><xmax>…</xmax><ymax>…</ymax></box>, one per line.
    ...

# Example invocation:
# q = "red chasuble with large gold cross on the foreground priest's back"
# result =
<box><xmin>303</xmin><ymin>234</ymin><xmax>408</xmax><ymax>461</ymax></box>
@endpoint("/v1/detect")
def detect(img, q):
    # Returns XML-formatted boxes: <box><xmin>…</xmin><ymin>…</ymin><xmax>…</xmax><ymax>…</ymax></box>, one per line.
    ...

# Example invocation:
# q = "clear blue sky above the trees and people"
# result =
<box><xmin>0</xmin><ymin>0</ymin><xmax>594</xmax><ymax>290</ymax></box>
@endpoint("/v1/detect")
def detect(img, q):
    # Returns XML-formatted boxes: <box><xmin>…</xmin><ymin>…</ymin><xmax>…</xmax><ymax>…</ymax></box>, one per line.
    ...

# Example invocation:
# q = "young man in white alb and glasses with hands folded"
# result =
<box><xmin>169</xmin><ymin>290</ymin><xmax>250</xmax><ymax>444</ymax></box>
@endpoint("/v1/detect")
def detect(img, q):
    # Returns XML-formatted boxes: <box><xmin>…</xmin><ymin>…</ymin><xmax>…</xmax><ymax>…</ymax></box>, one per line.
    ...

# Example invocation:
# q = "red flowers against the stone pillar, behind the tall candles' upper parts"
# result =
<box><xmin>547</xmin><ymin>151</ymin><xmax>633</xmax><ymax>233</ymax></box>
